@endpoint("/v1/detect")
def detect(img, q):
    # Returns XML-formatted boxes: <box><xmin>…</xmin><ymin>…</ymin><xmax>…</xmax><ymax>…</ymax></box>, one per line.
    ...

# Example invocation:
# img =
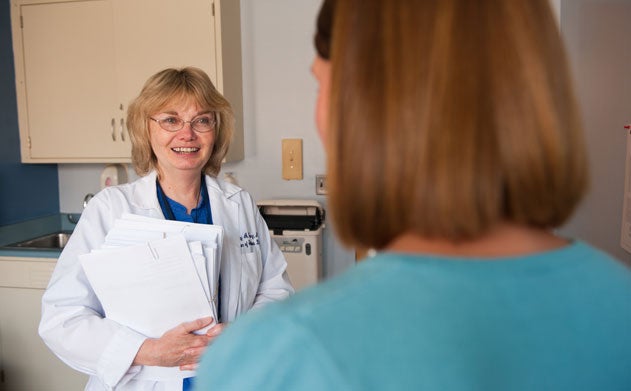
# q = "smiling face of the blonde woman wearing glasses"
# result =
<box><xmin>149</xmin><ymin>100</ymin><xmax>216</xmax><ymax>176</ymax></box>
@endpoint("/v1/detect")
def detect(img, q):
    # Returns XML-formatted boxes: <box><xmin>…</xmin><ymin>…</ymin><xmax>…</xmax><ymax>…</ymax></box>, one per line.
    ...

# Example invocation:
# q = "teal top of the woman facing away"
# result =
<box><xmin>196</xmin><ymin>241</ymin><xmax>631</xmax><ymax>391</ymax></box>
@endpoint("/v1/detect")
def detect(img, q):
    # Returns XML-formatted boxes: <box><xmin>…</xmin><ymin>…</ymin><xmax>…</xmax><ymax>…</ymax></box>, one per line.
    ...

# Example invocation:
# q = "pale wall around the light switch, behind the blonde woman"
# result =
<box><xmin>59</xmin><ymin>0</ymin><xmax>354</xmax><ymax>277</ymax></box>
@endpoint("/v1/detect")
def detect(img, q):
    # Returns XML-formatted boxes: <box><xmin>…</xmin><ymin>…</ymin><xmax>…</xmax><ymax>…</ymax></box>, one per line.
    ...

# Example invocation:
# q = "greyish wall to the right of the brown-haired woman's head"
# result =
<box><xmin>561</xmin><ymin>0</ymin><xmax>631</xmax><ymax>264</ymax></box>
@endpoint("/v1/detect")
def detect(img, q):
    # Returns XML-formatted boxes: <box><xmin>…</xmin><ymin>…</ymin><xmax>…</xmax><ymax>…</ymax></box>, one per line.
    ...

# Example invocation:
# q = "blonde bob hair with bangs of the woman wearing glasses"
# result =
<box><xmin>127</xmin><ymin>67</ymin><xmax>234</xmax><ymax>177</ymax></box>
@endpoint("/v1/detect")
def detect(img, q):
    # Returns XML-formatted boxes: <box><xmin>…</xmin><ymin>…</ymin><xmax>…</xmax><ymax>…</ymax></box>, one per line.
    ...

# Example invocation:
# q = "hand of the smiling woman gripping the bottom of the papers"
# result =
<box><xmin>132</xmin><ymin>317</ymin><xmax>215</xmax><ymax>369</ymax></box>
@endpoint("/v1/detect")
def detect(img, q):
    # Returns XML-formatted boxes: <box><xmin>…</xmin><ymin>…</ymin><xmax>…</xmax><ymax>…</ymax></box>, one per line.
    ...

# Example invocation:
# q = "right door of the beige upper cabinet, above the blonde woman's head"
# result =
<box><xmin>114</xmin><ymin>0</ymin><xmax>217</xmax><ymax>120</ymax></box>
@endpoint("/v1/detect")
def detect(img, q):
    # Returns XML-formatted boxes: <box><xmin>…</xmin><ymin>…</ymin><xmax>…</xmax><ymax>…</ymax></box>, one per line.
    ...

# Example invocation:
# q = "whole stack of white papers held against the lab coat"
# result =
<box><xmin>79</xmin><ymin>214</ymin><xmax>223</xmax><ymax>338</ymax></box>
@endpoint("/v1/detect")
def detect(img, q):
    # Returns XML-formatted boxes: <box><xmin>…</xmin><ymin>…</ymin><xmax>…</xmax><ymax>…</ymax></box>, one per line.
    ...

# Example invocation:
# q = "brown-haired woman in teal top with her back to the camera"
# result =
<box><xmin>198</xmin><ymin>0</ymin><xmax>631</xmax><ymax>391</ymax></box>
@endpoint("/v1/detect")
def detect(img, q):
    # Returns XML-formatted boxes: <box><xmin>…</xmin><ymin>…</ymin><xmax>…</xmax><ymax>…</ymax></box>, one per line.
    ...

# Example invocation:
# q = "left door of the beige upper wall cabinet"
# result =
<box><xmin>14</xmin><ymin>1</ymin><xmax>130</xmax><ymax>161</ymax></box>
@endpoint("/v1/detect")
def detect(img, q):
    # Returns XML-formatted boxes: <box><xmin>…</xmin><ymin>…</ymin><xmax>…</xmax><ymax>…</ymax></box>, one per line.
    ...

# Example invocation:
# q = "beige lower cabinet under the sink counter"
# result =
<box><xmin>0</xmin><ymin>257</ymin><xmax>88</xmax><ymax>391</ymax></box>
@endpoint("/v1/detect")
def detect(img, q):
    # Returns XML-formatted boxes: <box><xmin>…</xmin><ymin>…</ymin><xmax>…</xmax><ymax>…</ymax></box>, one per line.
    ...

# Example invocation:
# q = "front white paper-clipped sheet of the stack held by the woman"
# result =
<box><xmin>79</xmin><ymin>235</ymin><xmax>216</xmax><ymax>338</ymax></box>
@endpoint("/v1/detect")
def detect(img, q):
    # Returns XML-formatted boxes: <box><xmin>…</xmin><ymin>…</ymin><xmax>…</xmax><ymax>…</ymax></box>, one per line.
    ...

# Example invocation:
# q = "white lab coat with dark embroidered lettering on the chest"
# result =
<box><xmin>39</xmin><ymin>172</ymin><xmax>293</xmax><ymax>391</ymax></box>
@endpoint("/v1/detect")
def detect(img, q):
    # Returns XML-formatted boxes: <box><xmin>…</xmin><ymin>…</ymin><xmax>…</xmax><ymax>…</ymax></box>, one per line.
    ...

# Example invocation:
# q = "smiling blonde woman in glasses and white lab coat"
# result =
<box><xmin>39</xmin><ymin>67</ymin><xmax>293</xmax><ymax>390</ymax></box>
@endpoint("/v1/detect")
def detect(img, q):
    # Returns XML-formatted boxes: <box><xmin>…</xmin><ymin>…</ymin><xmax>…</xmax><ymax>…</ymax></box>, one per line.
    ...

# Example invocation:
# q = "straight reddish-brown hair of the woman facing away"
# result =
<box><xmin>315</xmin><ymin>0</ymin><xmax>588</xmax><ymax>249</ymax></box>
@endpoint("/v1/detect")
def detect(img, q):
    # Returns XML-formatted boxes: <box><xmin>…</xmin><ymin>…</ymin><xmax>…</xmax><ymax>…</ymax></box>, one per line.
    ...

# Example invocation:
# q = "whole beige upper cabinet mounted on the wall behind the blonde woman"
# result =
<box><xmin>11</xmin><ymin>0</ymin><xmax>243</xmax><ymax>163</ymax></box>
